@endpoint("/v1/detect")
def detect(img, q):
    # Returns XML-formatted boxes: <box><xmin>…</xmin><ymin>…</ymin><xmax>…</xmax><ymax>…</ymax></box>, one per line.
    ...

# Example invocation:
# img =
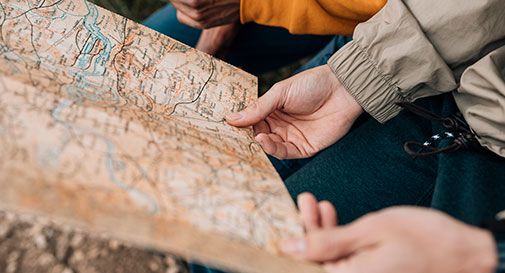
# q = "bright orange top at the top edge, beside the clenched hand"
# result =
<box><xmin>240</xmin><ymin>0</ymin><xmax>386</xmax><ymax>35</ymax></box>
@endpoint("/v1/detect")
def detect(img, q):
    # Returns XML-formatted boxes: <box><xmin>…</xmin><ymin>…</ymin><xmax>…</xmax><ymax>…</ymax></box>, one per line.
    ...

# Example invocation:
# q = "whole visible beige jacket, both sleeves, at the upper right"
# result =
<box><xmin>328</xmin><ymin>0</ymin><xmax>505</xmax><ymax>157</ymax></box>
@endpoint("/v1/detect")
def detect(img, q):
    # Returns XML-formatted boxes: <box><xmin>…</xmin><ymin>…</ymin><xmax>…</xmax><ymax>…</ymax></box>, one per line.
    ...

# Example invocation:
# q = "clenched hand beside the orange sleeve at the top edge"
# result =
<box><xmin>170</xmin><ymin>0</ymin><xmax>240</xmax><ymax>29</ymax></box>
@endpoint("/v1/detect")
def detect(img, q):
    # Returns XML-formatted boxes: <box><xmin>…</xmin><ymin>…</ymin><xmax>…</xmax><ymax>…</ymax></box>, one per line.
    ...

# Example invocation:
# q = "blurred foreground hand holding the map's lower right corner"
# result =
<box><xmin>281</xmin><ymin>194</ymin><xmax>497</xmax><ymax>273</ymax></box>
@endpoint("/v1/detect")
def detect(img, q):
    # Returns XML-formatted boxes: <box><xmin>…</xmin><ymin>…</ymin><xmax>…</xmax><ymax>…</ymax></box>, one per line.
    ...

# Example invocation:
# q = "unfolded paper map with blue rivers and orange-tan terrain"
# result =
<box><xmin>0</xmin><ymin>0</ymin><xmax>312</xmax><ymax>267</ymax></box>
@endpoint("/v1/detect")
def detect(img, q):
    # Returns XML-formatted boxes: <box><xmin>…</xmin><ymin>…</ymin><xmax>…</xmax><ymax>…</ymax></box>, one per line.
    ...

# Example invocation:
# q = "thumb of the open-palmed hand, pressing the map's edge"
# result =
<box><xmin>225</xmin><ymin>84</ymin><xmax>285</xmax><ymax>127</ymax></box>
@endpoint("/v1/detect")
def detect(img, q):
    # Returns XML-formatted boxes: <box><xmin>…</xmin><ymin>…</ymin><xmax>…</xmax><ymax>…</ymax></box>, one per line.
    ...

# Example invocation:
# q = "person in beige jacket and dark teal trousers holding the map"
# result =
<box><xmin>156</xmin><ymin>0</ymin><xmax>505</xmax><ymax>273</ymax></box>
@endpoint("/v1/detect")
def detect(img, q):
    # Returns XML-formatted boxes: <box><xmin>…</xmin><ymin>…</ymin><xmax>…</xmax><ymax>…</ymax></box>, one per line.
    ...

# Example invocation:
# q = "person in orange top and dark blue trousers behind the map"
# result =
<box><xmin>143</xmin><ymin>0</ymin><xmax>386</xmax><ymax>75</ymax></box>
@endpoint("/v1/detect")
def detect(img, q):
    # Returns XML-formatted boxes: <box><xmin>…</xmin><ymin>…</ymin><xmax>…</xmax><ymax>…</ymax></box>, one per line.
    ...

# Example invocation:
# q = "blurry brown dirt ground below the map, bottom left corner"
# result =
<box><xmin>0</xmin><ymin>211</ymin><xmax>187</xmax><ymax>273</ymax></box>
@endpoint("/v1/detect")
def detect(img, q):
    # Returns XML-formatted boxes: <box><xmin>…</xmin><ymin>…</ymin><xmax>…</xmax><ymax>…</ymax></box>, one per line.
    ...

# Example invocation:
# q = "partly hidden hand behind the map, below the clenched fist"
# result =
<box><xmin>196</xmin><ymin>24</ymin><xmax>240</xmax><ymax>58</ymax></box>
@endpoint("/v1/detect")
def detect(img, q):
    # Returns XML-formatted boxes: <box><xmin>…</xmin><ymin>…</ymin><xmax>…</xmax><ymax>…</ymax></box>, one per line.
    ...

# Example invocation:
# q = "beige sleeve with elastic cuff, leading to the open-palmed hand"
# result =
<box><xmin>328</xmin><ymin>0</ymin><xmax>505</xmax><ymax>122</ymax></box>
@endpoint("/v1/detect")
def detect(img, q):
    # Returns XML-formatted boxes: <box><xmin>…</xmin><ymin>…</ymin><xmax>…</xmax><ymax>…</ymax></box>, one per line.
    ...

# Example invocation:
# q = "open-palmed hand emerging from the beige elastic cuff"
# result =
<box><xmin>226</xmin><ymin>65</ymin><xmax>363</xmax><ymax>159</ymax></box>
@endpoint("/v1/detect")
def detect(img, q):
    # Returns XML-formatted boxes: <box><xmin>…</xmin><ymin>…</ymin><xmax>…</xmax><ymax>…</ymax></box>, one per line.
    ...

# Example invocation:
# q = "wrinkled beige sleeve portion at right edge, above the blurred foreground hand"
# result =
<box><xmin>454</xmin><ymin>47</ymin><xmax>505</xmax><ymax>157</ymax></box>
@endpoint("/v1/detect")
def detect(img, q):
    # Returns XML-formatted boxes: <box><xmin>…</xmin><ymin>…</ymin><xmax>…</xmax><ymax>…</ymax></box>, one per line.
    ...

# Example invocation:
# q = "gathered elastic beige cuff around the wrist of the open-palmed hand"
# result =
<box><xmin>328</xmin><ymin>41</ymin><xmax>406</xmax><ymax>123</ymax></box>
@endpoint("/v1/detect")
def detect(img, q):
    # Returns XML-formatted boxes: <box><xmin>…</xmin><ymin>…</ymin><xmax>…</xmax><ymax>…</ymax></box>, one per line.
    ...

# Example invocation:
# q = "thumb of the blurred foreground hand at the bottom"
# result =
<box><xmin>281</xmin><ymin>221</ymin><xmax>373</xmax><ymax>262</ymax></box>
